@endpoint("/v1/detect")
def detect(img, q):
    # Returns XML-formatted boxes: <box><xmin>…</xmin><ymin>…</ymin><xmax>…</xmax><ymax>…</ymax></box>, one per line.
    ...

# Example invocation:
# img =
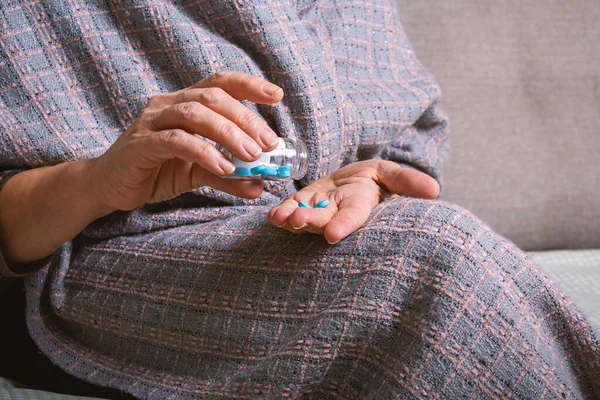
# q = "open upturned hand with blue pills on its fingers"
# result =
<box><xmin>268</xmin><ymin>160</ymin><xmax>440</xmax><ymax>244</ymax></box>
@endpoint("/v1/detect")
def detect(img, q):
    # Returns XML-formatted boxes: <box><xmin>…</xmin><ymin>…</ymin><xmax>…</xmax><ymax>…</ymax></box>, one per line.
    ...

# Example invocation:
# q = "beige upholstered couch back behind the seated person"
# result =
<box><xmin>398</xmin><ymin>0</ymin><xmax>600</xmax><ymax>250</ymax></box>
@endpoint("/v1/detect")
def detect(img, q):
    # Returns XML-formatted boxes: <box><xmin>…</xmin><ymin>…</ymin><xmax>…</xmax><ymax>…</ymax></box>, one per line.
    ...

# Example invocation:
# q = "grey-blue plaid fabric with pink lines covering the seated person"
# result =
<box><xmin>0</xmin><ymin>0</ymin><xmax>600</xmax><ymax>399</ymax></box>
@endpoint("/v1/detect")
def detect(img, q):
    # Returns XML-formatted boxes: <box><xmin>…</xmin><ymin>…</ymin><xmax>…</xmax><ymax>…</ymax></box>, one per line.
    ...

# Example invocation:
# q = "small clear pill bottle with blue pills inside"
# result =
<box><xmin>217</xmin><ymin>138</ymin><xmax>308</xmax><ymax>181</ymax></box>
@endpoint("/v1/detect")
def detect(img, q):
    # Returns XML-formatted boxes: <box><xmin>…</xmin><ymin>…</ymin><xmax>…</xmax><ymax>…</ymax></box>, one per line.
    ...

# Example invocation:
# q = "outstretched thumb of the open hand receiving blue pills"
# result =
<box><xmin>377</xmin><ymin>161</ymin><xmax>440</xmax><ymax>199</ymax></box>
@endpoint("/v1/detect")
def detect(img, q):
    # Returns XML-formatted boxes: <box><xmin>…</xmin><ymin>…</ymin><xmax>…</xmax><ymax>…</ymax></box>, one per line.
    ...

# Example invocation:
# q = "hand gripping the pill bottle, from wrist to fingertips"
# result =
<box><xmin>90</xmin><ymin>71</ymin><xmax>283</xmax><ymax>210</ymax></box>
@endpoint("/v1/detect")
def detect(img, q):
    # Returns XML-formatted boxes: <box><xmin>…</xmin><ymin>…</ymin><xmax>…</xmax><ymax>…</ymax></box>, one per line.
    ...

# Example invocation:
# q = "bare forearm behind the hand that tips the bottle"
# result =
<box><xmin>0</xmin><ymin>160</ymin><xmax>113</xmax><ymax>264</ymax></box>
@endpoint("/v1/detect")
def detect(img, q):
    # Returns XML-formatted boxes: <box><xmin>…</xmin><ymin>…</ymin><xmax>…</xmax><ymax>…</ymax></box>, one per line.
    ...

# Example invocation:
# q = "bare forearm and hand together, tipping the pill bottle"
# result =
<box><xmin>0</xmin><ymin>72</ymin><xmax>283</xmax><ymax>272</ymax></box>
